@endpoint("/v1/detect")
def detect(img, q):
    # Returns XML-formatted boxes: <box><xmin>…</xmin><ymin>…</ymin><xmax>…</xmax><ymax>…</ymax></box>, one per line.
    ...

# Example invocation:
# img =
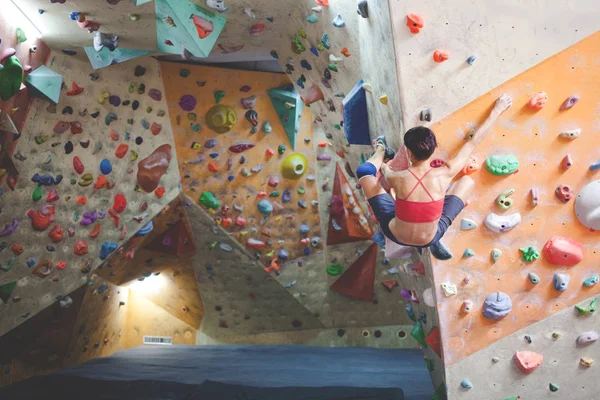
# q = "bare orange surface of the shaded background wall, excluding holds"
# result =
<box><xmin>161</xmin><ymin>63</ymin><xmax>318</xmax><ymax>265</ymax></box>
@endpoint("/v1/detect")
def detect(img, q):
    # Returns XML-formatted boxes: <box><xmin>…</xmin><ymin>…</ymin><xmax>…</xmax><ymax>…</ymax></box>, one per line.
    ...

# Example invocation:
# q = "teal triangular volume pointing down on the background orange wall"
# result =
<box><xmin>267</xmin><ymin>85</ymin><xmax>303</xmax><ymax>150</ymax></box>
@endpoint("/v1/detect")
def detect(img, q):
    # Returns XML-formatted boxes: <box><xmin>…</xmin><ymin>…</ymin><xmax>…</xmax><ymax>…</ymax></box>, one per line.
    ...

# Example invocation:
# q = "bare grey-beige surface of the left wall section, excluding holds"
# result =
<box><xmin>0</xmin><ymin>54</ymin><xmax>179</xmax><ymax>333</ymax></box>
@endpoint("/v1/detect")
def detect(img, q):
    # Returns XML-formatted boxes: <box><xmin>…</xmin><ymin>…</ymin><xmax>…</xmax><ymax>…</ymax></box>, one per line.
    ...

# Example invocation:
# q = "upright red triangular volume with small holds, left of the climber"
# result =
<box><xmin>327</xmin><ymin>164</ymin><xmax>373</xmax><ymax>245</ymax></box>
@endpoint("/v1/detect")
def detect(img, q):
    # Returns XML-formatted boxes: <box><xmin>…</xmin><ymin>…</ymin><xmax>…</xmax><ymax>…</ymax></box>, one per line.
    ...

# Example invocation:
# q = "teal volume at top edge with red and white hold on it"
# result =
<box><xmin>154</xmin><ymin>0</ymin><xmax>227</xmax><ymax>58</ymax></box>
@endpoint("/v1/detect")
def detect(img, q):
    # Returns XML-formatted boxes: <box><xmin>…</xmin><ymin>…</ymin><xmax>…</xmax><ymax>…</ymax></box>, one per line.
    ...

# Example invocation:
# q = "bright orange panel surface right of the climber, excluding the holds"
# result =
<box><xmin>432</xmin><ymin>32</ymin><xmax>600</xmax><ymax>365</ymax></box>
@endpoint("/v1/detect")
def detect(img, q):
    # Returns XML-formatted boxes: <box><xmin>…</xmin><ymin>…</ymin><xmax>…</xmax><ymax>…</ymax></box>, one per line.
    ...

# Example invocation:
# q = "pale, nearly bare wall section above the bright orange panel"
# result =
<box><xmin>390</xmin><ymin>0</ymin><xmax>600</xmax><ymax>125</ymax></box>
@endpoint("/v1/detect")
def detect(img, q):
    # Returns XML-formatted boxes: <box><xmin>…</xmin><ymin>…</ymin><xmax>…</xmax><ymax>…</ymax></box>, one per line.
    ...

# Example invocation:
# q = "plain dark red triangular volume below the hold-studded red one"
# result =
<box><xmin>329</xmin><ymin>243</ymin><xmax>378</xmax><ymax>301</ymax></box>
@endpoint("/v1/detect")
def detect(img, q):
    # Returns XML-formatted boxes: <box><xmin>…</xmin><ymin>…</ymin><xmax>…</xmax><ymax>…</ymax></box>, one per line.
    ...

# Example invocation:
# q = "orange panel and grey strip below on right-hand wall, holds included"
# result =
<box><xmin>432</xmin><ymin>33</ymin><xmax>600</xmax><ymax>399</ymax></box>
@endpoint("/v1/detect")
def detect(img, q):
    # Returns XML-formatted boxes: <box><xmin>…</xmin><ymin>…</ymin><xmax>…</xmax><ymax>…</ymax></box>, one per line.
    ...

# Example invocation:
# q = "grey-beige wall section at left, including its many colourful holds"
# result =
<box><xmin>0</xmin><ymin>54</ymin><xmax>179</xmax><ymax>333</ymax></box>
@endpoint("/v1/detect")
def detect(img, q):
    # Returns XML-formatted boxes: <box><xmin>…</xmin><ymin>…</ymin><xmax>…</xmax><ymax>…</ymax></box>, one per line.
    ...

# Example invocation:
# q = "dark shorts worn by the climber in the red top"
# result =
<box><xmin>369</xmin><ymin>193</ymin><xmax>465</xmax><ymax>248</ymax></box>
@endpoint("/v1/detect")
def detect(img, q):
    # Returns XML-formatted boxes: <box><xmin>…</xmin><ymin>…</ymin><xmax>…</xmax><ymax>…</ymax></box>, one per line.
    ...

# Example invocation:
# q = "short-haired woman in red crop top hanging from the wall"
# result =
<box><xmin>356</xmin><ymin>94</ymin><xmax>512</xmax><ymax>260</ymax></box>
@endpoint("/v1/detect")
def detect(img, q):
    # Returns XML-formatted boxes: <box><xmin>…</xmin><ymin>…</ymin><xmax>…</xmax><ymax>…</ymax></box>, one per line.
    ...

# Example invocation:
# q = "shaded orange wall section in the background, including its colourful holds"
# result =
<box><xmin>161</xmin><ymin>63</ymin><xmax>322</xmax><ymax>268</ymax></box>
